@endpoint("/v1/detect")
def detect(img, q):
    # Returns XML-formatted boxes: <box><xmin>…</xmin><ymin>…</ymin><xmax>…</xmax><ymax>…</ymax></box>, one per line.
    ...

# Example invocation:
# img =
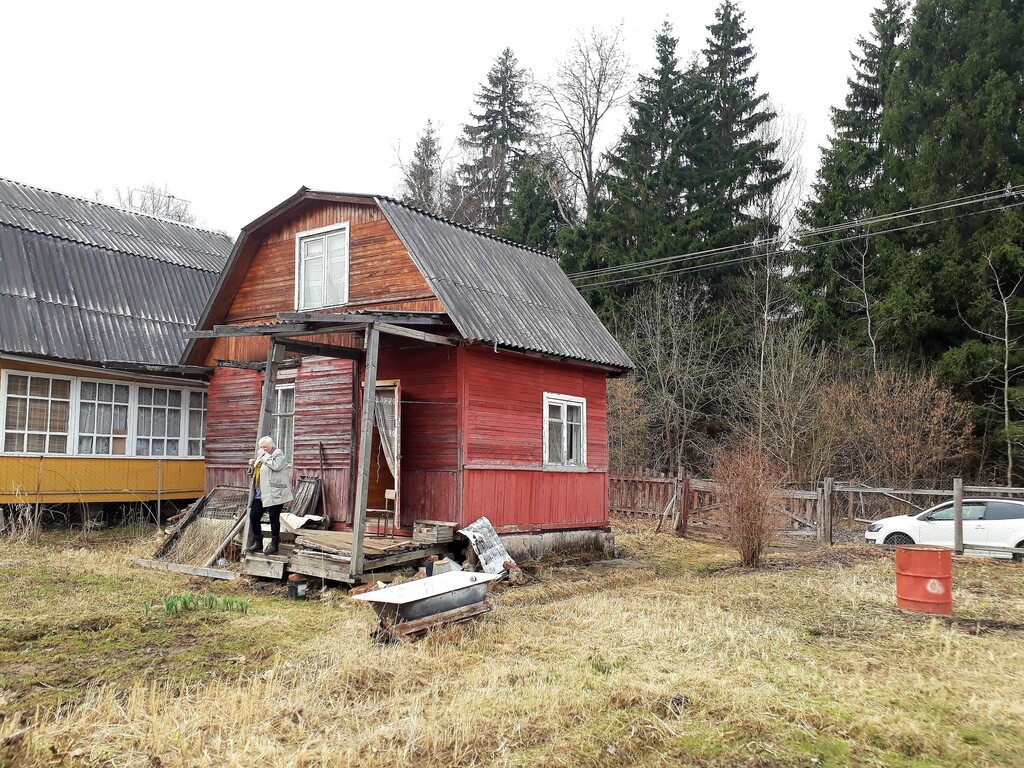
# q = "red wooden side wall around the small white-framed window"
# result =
<box><xmin>459</xmin><ymin>348</ymin><xmax>608</xmax><ymax>530</ymax></box>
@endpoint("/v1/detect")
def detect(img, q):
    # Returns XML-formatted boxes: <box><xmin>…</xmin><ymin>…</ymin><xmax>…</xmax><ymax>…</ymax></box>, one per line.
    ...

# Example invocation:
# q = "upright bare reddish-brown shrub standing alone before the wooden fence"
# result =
<box><xmin>715</xmin><ymin>437</ymin><xmax>785</xmax><ymax>568</ymax></box>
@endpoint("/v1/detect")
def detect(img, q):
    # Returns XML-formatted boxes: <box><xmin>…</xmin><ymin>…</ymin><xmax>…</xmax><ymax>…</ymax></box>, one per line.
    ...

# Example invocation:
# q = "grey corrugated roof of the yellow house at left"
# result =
<box><xmin>0</xmin><ymin>178</ymin><xmax>231</xmax><ymax>366</ymax></box>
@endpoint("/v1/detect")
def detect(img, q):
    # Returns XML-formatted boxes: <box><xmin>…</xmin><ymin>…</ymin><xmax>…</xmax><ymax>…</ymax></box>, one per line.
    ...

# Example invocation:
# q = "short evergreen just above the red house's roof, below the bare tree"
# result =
<box><xmin>497</xmin><ymin>159</ymin><xmax>560</xmax><ymax>252</ymax></box>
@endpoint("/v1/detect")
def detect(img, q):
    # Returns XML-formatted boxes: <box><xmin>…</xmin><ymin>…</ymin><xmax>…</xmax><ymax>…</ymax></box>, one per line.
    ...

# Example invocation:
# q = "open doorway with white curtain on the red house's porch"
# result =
<box><xmin>367</xmin><ymin>380</ymin><xmax>401</xmax><ymax>532</ymax></box>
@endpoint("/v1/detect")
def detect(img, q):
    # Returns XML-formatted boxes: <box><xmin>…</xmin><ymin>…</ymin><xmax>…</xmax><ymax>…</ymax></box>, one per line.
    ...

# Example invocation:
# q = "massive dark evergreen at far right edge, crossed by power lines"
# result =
<box><xmin>879</xmin><ymin>0</ymin><xmax>1024</xmax><ymax>361</ymax></box>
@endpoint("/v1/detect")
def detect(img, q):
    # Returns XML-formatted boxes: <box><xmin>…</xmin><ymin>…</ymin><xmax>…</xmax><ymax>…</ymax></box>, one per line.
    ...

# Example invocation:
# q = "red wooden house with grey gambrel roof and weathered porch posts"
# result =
<box><xmin>182</xmin><ymin>187</ymin><xmax>632</xmax><ymax>573</ymax></box>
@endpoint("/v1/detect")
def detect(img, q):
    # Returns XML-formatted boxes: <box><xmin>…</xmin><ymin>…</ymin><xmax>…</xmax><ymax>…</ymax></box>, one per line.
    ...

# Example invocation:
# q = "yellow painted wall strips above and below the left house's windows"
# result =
<box><xmin>0</xmin><ymin>359</ymin><xmax>205</xmax><ymax>505</ymax></box>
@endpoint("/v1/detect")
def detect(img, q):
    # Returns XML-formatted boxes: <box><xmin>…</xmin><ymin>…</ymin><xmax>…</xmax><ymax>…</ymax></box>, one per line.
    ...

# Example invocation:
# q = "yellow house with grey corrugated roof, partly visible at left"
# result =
<box><xmin>0</xmin><ymin>179</ymin><xmax>231</xmax><ymax>514</ymax></box>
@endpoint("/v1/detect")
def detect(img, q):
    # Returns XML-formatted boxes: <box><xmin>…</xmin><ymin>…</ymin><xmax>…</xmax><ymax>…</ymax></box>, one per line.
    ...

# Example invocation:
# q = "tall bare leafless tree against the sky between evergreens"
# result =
<box><xmin>538</xmin><ymin>24</ymin><xmax>630</xmax><ymax>215</ymax></box>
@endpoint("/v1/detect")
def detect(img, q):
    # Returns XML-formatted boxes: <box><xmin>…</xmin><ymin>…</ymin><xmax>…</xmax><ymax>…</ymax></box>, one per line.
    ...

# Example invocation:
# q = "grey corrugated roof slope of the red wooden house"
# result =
<box><xmin>376</xmin><ymin>198</ymin><xmax>633</xmax><ymax>369</ymax></box>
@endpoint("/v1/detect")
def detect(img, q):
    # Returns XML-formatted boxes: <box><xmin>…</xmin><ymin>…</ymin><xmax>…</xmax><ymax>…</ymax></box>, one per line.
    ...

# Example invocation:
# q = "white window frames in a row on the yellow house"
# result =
<box><xmin>0</xmin><ymin>368</ymin><xmax>209</xmax><ymax>461</ymax></box>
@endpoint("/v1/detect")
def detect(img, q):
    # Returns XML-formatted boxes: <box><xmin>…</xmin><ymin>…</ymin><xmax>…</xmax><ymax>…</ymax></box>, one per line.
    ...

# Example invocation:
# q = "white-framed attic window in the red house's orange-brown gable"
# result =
<box><xmin>295</xmin><ymin>223</ymin><xmax>348</xmax><ymax>309</ymax></box>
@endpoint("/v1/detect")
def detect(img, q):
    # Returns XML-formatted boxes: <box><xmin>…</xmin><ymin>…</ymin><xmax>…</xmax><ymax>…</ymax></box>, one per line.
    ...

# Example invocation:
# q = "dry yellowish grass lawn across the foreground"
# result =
<box><xmin>0</xmin><ymin>530</ymin><xmax>1024</xmax><ymax>768</ymax></box>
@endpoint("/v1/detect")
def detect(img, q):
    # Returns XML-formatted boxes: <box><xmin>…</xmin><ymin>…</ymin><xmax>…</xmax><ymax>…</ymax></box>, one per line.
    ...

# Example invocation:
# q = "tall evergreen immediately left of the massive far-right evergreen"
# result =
<box><xmin>792</xmin><ymin>0</ymin><xmax>906</xmax><ymax>348</ymax></box>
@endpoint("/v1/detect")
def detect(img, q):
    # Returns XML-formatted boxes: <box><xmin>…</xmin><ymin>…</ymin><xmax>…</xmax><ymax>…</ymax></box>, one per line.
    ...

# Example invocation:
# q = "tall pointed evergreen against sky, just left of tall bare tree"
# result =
<box><xmin>459</xmin><ymin>48</ymin><xmax>535</xmax><ymax>231</ymax></box>
